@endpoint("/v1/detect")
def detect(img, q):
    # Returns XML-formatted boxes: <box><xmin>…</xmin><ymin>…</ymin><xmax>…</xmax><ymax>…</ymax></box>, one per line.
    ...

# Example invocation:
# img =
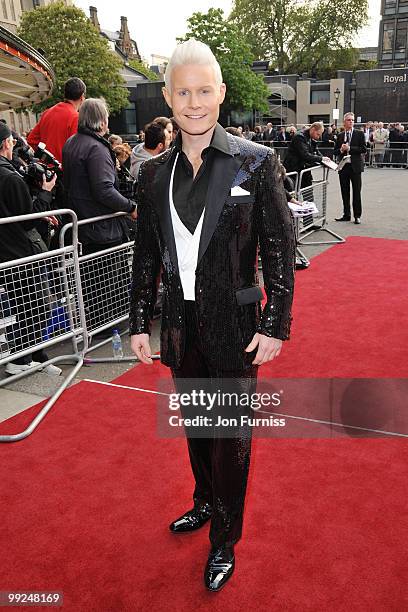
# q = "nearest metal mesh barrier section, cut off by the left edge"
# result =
<box><xmin>0</xmin><ymin>209</ymin><xmax>88</xmax><ymax>442</ymax></box>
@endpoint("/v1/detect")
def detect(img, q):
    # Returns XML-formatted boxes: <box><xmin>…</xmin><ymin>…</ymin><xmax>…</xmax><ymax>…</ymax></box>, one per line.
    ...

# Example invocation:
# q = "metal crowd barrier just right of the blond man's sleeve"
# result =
<box><xmin>297</xmin><ymin>166</ymin><xmax>345</xmax><ymax>246</ymax></box>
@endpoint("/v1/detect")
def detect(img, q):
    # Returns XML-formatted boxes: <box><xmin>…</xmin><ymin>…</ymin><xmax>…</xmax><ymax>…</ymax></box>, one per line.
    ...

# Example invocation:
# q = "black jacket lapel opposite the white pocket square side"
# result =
<box><xmin>153</xmin><ymin>154</ymin><xmax>179</xmax><ymax>274</ymax></box>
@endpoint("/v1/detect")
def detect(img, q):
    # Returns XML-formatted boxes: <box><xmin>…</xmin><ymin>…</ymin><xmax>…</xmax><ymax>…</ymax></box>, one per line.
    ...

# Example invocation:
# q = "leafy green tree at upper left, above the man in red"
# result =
<box><xmin>18</xmin><ymin>3</ymin><xmax>129</xmax><ymax>112</ymax></box>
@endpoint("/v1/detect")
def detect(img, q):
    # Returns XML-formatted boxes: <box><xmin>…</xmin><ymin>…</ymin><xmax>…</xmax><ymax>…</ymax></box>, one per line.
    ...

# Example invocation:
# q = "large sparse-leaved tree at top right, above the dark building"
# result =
<box><xmin>229</xmin><ymin>0</ymin><xmax>368</xmax><ymax>76</ymax></box>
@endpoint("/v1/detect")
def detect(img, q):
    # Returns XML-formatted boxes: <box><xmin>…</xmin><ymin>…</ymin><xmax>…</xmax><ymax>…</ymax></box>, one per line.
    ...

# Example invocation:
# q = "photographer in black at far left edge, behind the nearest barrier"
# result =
<box><xmin>0</xmin><ymin>123</ymin><xmax>61</xmax><ymax>375</ymax></box>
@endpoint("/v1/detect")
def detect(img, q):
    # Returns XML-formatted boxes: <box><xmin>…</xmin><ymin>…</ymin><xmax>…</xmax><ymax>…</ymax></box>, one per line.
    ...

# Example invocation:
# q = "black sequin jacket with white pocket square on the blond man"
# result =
<box><xmin>130</xmin><ymin>126</ymin><xmax>295</xmax><ymax>371</ymax></box>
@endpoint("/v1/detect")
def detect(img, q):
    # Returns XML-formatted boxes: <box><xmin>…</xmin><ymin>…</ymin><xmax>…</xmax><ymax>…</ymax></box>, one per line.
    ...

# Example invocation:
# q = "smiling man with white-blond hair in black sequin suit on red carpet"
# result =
<box><xmin>130</xmin><ymin>40</ymin><xmax>295</xmax><ymax>591</ymax></box>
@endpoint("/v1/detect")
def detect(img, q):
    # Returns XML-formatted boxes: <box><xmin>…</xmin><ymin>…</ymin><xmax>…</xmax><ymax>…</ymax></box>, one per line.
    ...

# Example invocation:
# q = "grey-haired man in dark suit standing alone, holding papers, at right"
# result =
<box><xmin>334</xmin><ymin>113</ymin><xmax>367</xmax><ymax>224</ymax></box>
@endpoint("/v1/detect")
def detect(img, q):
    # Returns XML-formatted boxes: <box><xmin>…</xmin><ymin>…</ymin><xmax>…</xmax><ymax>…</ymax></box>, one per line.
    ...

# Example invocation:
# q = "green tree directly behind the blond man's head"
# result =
<box><xmin>178</xmin><ymin>8</ymin><xmax>269</xmax><ymax>112</ymax></box>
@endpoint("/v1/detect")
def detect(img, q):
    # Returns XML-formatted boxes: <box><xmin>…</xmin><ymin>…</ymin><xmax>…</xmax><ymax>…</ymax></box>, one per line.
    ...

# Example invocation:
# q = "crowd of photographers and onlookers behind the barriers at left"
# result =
<box><xmin>0</xmin><ymin>78</ymin><xmax>183</xmax><ymax>375</ymax></box>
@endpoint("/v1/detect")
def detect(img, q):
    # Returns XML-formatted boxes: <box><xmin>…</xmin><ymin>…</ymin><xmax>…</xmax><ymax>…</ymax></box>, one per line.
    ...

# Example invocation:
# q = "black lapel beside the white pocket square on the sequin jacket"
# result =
<box><xmin>197</xmin><ymin>150</ymin><xmax>244</xmax><ymax>264</ymax></box>
